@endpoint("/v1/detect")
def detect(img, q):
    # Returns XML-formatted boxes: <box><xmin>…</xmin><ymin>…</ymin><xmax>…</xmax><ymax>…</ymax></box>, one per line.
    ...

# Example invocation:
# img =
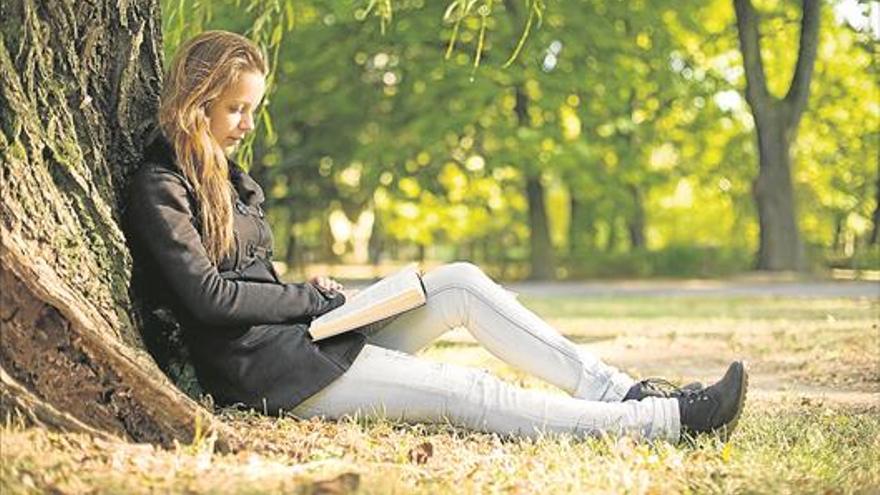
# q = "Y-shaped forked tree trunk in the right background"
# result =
<box><xmin>733</xmin><ymin>0</ymin><xmax>821</xmax><ymax>270</ymax></box>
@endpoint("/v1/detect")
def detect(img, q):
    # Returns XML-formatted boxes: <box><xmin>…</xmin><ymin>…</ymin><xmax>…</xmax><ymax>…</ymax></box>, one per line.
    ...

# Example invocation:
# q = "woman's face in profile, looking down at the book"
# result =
<box><xmin>208</xmin><ymin>71</ymin><xmax>266</xmax><ymax>155</ymax></box>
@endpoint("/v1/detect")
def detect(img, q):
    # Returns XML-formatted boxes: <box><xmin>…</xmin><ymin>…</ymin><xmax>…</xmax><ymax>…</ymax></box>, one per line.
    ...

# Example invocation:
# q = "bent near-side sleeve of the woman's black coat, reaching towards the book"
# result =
<box><xmin>127</xmin><ymin>166</ymin><xmax>345</xmax><ymax>326</ymax></box>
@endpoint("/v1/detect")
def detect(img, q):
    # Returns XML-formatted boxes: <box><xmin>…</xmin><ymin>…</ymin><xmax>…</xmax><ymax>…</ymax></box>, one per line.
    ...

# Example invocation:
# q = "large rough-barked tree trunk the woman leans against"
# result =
<box><xmin>0</xmin><ymin>0</ymin><xmax>234</xmax><ymax>446</ymax></box>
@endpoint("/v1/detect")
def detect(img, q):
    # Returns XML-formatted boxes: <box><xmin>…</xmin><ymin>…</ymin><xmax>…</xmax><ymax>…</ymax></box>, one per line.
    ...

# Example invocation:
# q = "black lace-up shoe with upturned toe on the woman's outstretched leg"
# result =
<box><xmin>678</xmin><ymin>361</ymin><xmax>749</xmax><ymax>441</ymax></box>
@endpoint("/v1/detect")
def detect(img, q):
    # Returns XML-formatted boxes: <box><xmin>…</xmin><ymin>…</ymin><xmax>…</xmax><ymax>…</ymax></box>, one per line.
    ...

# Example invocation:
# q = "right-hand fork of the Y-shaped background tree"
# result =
<box><xmin>785</xmin><ymin>0</ymin><xmax>822</xmax><ymax>130</ymax></box>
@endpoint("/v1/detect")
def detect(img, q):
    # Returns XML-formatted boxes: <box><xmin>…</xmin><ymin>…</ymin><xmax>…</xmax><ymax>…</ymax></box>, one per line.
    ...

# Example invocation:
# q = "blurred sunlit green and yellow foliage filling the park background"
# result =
<box><xmin>163</xmin><ymin>0</ymin><xmax>880</xmax><ymax>277</ymax></box>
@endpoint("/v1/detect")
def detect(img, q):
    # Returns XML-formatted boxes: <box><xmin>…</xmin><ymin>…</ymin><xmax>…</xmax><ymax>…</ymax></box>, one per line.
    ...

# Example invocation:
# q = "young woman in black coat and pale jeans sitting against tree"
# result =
<box><xmin>126</xmin><ymin>31</ymin><xmax>747</xmax><ymax>441</ymax></box>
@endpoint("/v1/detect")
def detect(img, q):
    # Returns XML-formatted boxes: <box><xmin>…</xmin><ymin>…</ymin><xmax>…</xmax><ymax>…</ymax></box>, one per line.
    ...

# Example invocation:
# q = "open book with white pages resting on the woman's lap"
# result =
<box><xmin>309</xmin><ymin>263</ymin><xmax>427</xmax><ymax>340</ymax></box>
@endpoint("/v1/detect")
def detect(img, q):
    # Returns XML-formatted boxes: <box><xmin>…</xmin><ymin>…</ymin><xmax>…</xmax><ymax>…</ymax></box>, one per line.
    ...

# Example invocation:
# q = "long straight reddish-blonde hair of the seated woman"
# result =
<box><xmin>159</xmin><ymin>31</ymin><xmax>267</xmax><ymax>264</ymax></box>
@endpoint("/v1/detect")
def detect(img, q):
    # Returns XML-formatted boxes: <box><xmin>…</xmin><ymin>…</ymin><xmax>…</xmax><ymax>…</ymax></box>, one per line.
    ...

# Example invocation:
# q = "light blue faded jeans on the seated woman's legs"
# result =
<box><xmin>293</xmin><ymin>263</ymin><xmax>680</xmax><ymax>441</ymax></box>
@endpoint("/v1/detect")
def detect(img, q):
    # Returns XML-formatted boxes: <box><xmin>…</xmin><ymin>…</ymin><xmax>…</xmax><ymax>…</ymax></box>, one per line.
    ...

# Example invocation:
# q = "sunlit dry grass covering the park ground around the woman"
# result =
<box><xmin>0</xmin><ymin>297</ymin><xmax>880</xmax><ymax>494</ymax></box>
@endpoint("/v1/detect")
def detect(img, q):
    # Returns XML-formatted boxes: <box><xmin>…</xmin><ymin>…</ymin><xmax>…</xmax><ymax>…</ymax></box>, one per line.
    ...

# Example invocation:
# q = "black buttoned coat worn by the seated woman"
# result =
<box><xmin>125</xmin><ymin>135</ymin><xmax>365</xmax><ymax>414</ymax></box>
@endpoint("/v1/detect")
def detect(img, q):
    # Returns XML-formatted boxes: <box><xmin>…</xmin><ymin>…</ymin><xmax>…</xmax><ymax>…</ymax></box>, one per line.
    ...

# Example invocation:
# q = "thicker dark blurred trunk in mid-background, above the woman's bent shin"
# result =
<box><xmin>514</xmin><ymin>87</ymin><xmax>556</xmax><ymax>280</ymax></box>
